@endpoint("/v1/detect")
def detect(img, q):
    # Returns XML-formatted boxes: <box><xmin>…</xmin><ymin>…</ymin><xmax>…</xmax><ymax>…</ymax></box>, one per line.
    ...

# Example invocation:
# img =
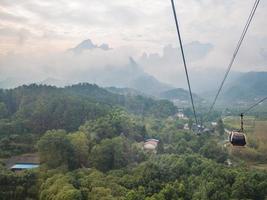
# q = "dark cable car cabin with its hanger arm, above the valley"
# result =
<box><xmin>229</xmin><ymin>113</ymin><xmax>247</xmax><ymax>147</ymax></box>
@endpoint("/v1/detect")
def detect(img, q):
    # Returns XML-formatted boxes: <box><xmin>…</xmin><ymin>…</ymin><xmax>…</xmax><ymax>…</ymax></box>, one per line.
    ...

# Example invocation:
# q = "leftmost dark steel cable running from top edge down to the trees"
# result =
<box><xmin>171</xmin><ymin>0</ymin><xmax>198</xmax><ymax>124</ymax></box>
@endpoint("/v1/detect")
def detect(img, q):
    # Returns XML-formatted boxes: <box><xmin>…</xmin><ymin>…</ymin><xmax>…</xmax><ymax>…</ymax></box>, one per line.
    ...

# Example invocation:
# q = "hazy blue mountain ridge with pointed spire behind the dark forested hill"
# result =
<box><xmin>0</xmin><ymin>57</ymin><xmax>173</xmax><ymax>96</ymax></box>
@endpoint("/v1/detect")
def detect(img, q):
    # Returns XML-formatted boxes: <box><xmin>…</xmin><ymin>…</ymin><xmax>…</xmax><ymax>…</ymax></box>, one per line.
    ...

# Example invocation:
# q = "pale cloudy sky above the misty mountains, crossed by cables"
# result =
<box><xmin>0</xmin><ymin>0</ymin><xmax>267</xmax><ymax>85</ymax></box>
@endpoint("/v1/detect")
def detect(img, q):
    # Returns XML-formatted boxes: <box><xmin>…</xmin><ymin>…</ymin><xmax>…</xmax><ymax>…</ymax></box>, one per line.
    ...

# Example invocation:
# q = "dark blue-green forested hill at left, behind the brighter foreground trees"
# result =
<box><xmin>0</xmin><ymin>83</ymin><xmax>176</xmax><ymax>136</ymax></box>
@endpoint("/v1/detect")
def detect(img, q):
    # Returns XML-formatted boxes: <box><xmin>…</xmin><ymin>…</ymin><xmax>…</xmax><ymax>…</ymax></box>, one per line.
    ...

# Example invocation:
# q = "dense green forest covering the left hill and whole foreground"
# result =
<box><xmin>0</xmin><ymin>84</ymin><xmax>267</xmax><ymax>200</ymax></box>
